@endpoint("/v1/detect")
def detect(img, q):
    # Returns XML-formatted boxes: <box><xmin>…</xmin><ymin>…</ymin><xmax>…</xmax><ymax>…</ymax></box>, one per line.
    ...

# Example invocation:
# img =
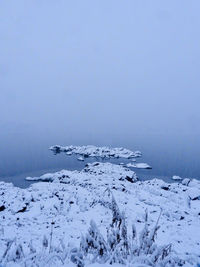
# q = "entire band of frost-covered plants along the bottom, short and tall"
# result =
<box><xmin>0</xmin><ymin>195</ymin><xmax>185</xmax><ymax>267</ymax></box>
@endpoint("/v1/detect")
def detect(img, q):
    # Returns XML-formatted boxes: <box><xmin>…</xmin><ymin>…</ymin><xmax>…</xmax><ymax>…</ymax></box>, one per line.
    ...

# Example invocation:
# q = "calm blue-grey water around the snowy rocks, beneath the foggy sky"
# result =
<box><xmin>0</xmin><ymin>134</ymin><xmax>200</xmax><ymax>187</ymax></box>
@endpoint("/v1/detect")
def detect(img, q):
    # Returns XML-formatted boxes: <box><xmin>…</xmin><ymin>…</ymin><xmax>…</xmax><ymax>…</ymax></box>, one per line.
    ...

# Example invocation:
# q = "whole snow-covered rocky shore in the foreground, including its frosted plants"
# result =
<box><xmin>0</xmin><ymin>163</ymin><xmax>200</xmax><ymax>267</ymax></box>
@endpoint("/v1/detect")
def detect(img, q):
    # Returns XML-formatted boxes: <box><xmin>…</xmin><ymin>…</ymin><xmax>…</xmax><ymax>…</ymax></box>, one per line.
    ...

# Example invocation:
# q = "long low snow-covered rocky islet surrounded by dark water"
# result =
<box><xmin>49</xmin><ymin>145</ymin><xmax>142</xmax><ymax>159</ymax></box>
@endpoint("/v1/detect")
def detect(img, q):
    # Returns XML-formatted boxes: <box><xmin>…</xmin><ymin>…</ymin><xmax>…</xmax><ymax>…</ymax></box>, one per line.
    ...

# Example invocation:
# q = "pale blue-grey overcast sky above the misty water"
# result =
<box><xmin>0</xmin><ymin>0</ymin><xmax>200</xmax><ymax>144</ymax></box>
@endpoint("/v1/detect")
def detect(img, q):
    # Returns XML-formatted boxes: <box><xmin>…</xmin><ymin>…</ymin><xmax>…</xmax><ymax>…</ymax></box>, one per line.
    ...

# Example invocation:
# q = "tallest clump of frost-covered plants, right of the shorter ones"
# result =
<box><xmin>76</xmin><ymin>196</ymin><xmax>184</xmax><ymax>267</ymax></box>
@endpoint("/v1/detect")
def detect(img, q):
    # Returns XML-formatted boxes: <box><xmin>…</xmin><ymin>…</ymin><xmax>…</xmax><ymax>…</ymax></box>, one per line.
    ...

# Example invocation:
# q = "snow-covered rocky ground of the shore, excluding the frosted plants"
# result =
<box><xmin>0</xmin><ymin>163</ymin><xmax>200</xmax><ymax>267</ymax></box>
